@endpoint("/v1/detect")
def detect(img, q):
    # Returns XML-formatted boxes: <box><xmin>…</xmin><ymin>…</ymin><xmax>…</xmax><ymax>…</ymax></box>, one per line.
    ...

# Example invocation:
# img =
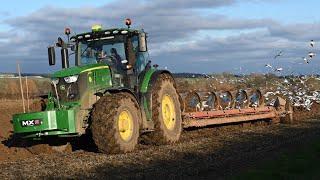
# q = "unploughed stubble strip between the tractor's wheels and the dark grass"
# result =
<box><xmin>0</xmin><ymin>117</ymin><xmax>320</xmax><ymax>179</ymax></box>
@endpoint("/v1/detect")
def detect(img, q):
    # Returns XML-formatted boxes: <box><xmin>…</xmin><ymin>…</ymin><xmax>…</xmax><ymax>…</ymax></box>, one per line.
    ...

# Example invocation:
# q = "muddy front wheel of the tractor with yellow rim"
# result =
<box><xmin>91</xmin><ymin>93</ymin><xmax>140</xmax><ymax>154</ymax></box>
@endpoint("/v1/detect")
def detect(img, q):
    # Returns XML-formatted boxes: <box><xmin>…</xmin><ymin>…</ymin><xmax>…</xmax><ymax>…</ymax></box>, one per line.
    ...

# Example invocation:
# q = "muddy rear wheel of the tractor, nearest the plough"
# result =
<box><xmin>148</xmin><ymin>74</ymin><xmax>182</xmax><ymax>145</ymax></box>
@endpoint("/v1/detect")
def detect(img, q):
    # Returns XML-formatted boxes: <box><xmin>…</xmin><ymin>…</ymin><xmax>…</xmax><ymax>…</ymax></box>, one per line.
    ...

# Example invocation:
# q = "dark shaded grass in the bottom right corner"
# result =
<box><xmin>232</xmin><ymin>142</ymin><xmax>320</xmax><ymax>180</ymax></box>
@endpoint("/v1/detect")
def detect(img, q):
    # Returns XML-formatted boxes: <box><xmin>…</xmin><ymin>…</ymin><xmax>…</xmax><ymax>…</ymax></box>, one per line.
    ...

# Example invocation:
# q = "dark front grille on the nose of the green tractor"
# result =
<box><xmin>51</xmin><ymin>75</ymin><xmax>86</xmax><ymax>103</ymax></box>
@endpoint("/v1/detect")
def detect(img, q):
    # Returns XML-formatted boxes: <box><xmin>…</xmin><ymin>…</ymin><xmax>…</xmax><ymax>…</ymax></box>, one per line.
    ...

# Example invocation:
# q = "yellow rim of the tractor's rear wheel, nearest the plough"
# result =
<box><xmin>161</xmin><ymin>95</ymin><xmax>176</xmax><ymax>130</ymax></box>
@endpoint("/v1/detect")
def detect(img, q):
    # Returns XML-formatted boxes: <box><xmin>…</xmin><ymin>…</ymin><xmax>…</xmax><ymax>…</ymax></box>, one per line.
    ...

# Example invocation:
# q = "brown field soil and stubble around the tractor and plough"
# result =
<box><xmin>0</xmin><ymin>101</ymin><xmax>320</xmax><ymax>179</ymax></box>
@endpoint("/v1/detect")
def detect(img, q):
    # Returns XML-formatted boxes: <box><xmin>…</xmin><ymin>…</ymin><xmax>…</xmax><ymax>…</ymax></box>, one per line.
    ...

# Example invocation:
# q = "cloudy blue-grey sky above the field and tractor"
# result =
<box><xmin>0</xmin><ymin>0</ymin><xmax>320</xmax><ymax>74</ymax></box>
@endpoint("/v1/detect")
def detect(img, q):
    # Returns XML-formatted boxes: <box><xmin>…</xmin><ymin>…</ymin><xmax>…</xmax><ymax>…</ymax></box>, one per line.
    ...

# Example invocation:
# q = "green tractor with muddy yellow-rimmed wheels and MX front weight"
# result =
<box><xmin>13</xmin><ymin>19</ymin><xmax>182</xmax><ymax>153</ymax></box>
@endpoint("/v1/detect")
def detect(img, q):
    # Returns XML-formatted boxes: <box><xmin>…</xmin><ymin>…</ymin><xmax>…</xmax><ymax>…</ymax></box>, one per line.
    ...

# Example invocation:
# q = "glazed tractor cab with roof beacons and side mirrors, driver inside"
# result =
<box><xmin>48</xmin><ymin>19</ymin><xmax>149</xmax><ymax>88</ymax></box>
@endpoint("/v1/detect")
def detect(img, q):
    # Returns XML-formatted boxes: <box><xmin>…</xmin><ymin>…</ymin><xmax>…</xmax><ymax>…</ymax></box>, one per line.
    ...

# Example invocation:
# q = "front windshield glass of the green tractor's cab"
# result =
<box><xmin>77</xmin><ymin>36</ymin><xmax>126</xmax><ymax>65</ymax></box>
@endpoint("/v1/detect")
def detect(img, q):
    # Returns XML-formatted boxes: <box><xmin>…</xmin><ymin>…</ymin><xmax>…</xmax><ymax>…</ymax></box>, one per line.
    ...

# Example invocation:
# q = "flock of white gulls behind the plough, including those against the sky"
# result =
<box><xmin>176</xmin><ymin>40</ymin><xmax>320</xmax><ymax>111</ymax></box>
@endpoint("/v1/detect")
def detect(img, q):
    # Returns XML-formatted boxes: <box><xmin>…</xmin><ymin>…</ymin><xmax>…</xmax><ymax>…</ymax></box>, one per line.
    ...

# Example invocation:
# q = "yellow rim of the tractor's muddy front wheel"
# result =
<box><xmin>118</xmin><ymin>110</ymin><xmax>133</xmax><ymax>141</ymax></box>
